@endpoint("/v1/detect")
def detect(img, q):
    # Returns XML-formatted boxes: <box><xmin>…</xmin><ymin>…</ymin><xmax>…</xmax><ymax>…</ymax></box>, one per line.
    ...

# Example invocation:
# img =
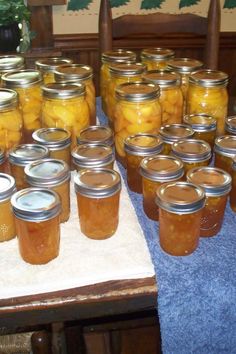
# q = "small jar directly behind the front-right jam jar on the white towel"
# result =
<box><xmin>71</xmin><ymin>144</ymin><xmax>115</xmax><ymax>171</ymax></box>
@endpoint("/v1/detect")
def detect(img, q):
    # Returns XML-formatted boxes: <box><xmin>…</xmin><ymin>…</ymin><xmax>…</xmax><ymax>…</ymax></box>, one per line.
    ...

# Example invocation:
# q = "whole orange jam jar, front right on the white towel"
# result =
<box><xmin>74</xmin><ymin>168</ymin><xmax>121</xmax><ymax>240</ymax></box>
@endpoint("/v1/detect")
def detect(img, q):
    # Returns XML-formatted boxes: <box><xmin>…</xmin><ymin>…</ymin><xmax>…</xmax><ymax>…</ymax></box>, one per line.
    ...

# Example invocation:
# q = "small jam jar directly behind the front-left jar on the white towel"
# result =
<box><xmin>24</xmin><ymin>159</ymin><xmax>70</xmax><ymax>222</ymax></box>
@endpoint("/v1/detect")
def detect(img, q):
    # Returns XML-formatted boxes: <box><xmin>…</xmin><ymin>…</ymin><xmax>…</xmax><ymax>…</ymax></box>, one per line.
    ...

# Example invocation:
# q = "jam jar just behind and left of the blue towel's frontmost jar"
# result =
<box><xmin>140</xmin><ymin>155</ymin><xmax>184</xmax><ymax>221</ymax></box>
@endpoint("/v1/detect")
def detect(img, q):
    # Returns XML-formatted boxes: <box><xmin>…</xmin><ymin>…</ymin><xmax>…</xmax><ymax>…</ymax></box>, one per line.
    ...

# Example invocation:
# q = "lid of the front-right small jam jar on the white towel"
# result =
<box><xmin>74</xmin><ymin>168</ymin><xmax>121</xmax><ymax>198</ymax></box>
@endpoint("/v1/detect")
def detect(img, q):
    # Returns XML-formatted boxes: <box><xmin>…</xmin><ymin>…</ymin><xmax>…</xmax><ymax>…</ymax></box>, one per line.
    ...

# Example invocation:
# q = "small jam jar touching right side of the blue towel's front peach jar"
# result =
<box><xmin>159</xmin><ymin>124</ymin><xmax>194</xmax><ymax>155</ymax></box>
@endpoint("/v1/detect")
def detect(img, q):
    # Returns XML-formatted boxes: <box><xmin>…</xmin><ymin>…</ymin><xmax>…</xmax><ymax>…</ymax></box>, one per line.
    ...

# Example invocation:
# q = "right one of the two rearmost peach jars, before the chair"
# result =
<box><xmin>141</xmin><ymin>48</ymin><xmax>175</xmax><ymax>70</ymax></box>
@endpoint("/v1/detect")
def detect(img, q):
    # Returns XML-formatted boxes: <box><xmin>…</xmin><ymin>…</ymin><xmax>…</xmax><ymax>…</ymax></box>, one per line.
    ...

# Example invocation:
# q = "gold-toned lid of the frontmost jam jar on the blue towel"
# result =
<box><xmin>156</xmin><ymin>182</ymin><xmax>205</xmax><ymax>214</ymax></box>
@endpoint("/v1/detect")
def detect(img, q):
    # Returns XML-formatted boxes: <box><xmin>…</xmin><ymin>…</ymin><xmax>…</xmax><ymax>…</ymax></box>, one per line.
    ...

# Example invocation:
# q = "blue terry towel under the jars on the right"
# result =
<box><xmin>97</xmin><ymin>100</ymin><xmax>236</xmax><ymax>354</ymax></box>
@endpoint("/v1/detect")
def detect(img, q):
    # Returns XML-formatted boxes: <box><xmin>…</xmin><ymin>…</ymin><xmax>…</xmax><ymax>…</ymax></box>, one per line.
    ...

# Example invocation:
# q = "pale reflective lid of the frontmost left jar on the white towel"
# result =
<box><xmin>11</xmin><ymin>188</ymin><xmax>61</xmax><ymax>222</ymax></box>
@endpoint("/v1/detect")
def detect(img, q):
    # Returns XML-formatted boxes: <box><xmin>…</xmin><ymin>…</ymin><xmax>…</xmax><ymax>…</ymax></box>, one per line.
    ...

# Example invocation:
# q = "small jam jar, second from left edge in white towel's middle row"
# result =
<box><xmin>9</xmin><ymin>144</ymin><xmax>49</xmax><ymax>189</ymax></box>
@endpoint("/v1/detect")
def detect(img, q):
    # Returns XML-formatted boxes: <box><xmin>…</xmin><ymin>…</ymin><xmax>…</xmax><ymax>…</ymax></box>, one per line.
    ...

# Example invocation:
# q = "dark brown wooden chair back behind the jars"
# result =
<box><xmin>99</xmin><ymin>0</ymin><xmax>220</xmax><ymax>69</ymax></box>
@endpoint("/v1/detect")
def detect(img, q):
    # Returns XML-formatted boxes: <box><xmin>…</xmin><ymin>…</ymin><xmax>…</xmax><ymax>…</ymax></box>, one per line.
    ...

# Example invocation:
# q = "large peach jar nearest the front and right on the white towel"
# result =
<box><xmin>42</xmin><ymin>83</ymin><xmax>89</xmax><ymax>149</ymax></box>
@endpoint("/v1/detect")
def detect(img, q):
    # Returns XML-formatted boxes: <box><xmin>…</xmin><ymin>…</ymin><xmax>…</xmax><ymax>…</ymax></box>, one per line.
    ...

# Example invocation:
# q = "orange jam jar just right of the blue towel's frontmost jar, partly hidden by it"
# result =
<box><xmin>186</xmin><ymin>167</ymin><xmax>232</xmax><ymax>237</ymax></box>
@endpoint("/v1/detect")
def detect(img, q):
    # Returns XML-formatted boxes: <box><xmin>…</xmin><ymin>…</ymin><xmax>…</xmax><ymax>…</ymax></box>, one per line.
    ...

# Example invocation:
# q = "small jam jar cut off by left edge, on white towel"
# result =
<box><xmin>0</xmin><ymin>173</ymin><xmax>16</xmax><ymax>242</ymax></box>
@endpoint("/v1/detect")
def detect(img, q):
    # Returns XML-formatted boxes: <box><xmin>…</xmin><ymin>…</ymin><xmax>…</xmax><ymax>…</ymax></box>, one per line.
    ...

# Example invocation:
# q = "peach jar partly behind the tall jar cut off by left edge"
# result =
<box><xmin>2</xmin><ymin>69</ymin><xmax>42</xmax><ymax>143</ymax></box>
